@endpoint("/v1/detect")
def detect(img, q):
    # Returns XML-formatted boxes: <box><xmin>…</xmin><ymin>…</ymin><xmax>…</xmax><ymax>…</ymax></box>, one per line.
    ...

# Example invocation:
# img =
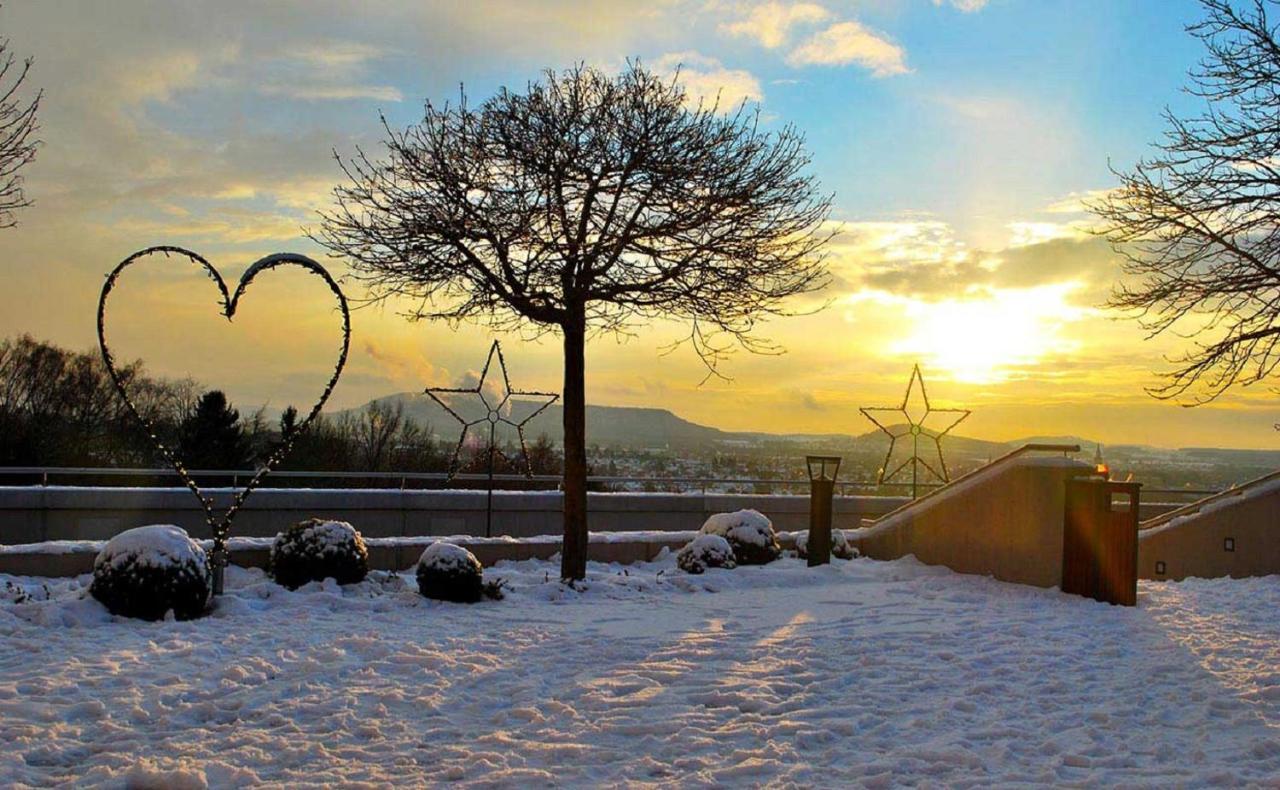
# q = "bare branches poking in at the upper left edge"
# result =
<box><xmin>0</xmin><ymin>13</ymin><xmax>42</xmax><ymax>228</ymax></box>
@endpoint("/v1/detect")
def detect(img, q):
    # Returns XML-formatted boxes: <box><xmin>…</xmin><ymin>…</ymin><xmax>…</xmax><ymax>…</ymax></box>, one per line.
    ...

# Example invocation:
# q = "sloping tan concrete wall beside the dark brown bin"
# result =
<box><xmin>855</xmin><ymin>456</ymin><xmax>1092</xmax><ymax>586</ymax></box>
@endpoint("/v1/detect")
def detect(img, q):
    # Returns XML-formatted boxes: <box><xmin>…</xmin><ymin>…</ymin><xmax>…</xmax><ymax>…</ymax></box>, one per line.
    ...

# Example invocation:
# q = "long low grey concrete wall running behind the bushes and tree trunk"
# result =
<box><xmin>0</xmin><ymin>487</ymin><xmax>906</xmax><ymax>544</ymax></box>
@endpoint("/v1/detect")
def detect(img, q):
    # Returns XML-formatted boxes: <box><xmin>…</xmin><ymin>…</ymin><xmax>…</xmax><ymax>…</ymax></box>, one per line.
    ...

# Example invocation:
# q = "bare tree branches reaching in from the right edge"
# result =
<box><xmin>1089</xmin><ymin>0</ymin><xmax>1280</xmax><ymax>403</ymax></box>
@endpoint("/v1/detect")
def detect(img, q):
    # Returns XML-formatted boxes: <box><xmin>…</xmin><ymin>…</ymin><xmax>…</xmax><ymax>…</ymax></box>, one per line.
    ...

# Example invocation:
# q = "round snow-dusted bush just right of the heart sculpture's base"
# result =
<box><xmin>270</xmin><ymin>519</ymin><xmax>369</xmax><ymax>590</ymax></box>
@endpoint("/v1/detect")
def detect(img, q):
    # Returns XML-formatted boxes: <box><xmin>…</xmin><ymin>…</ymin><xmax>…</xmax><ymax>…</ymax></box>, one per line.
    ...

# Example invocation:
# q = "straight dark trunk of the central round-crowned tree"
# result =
<box><xmin>561</xmin><ymin>311</ymin><xmax>586</xmax><ymax>580</ymax></box>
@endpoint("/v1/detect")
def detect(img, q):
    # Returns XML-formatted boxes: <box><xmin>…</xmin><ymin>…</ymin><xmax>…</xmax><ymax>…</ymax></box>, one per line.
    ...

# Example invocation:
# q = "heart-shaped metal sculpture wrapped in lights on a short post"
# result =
<box><xmin>97</xmin><ymin>246</ymin><xmax>351</xmax><ymax>594</ymax></box>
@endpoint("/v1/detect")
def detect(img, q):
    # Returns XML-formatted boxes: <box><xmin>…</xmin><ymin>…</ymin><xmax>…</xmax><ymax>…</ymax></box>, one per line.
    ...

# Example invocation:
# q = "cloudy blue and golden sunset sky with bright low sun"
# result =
<box><xmin>0</xmin><ymin>0</ymin><xmax>1280</xmax><ymax>448</ymax></box>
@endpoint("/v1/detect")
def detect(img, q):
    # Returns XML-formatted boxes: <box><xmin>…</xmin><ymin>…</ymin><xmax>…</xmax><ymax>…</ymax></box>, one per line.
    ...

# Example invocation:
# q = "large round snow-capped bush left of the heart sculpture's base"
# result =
<box><xmin>90</xmin><ymin>525</ymin><xmax>212</xmax><ymax>620</ymax></box>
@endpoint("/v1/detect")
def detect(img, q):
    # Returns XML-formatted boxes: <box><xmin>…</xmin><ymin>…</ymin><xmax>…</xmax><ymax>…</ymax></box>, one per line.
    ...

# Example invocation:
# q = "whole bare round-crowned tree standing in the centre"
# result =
<box><xmin>316</xmin><ymin>64</ymin><xmax>829</xmax><ymax>579</ymax></box>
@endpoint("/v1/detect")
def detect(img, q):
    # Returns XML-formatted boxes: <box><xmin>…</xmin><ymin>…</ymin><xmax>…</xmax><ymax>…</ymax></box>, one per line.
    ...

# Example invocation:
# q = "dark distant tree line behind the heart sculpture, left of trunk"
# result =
<box><xmin>0</xmin><ymin>335</ymin><xmax>561</xmax><ymax>485</ymax></box>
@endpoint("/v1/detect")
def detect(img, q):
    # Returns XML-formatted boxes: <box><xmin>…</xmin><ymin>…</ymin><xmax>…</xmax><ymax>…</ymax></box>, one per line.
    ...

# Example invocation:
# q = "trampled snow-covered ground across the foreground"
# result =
<box><xmin>0</xmin><ymin>554</ymin><xmax>1280</xmax><ymax>787</ymax></box>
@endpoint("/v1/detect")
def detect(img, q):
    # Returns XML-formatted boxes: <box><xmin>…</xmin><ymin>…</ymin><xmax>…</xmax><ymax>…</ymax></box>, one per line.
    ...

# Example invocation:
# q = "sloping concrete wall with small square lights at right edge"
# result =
<box><xmin>1138</xmin><ymin>487</ymin><xmax>1280</xmax><ymax>580</ymax></box>
